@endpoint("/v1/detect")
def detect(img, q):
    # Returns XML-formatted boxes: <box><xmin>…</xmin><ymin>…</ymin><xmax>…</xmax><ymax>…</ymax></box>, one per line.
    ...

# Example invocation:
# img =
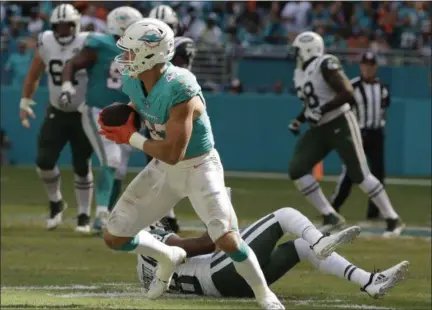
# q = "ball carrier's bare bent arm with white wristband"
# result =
<box><xmin>129</xmin><ymin>96</ymin><xmax>198</xmax><ymax>165</ymax></box>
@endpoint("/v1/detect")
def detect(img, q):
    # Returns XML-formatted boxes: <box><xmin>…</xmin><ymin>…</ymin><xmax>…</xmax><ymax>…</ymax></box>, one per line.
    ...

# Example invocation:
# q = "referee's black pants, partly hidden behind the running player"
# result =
<box><xmin>331</xmin><ymin>128</ymin><xmax>385</xmax><ymax>219</ymax></box>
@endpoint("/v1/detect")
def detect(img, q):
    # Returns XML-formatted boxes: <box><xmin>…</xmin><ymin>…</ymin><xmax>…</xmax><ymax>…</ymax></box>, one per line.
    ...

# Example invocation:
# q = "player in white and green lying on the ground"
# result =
<box><xmin>137</xmin><ymin>203</ymin><xmax>409</xmax><ymax>298</ymax></box>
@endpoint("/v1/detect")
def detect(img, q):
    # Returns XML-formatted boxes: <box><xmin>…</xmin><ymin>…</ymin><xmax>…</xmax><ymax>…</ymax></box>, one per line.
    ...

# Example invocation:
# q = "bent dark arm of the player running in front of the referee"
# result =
<box><xmin>321</xmin><ymin>57</ymin><xmax>355</xmax><ymax>114</ymax></box>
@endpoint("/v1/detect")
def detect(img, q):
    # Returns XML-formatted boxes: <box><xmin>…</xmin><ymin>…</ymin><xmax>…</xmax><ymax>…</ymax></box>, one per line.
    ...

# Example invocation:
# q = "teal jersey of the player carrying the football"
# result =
<box><xmin>123</xmin><ymin>63</ymin><xmax>214</xmax><ymax>158</ymax></box>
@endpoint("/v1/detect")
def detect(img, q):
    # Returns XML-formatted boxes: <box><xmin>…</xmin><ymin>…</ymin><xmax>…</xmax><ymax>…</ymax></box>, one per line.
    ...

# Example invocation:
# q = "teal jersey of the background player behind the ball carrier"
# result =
<box><xmin>84</xmin><ymin>32</ymin><xmax>129</xmax><ymax>109</ymax></box>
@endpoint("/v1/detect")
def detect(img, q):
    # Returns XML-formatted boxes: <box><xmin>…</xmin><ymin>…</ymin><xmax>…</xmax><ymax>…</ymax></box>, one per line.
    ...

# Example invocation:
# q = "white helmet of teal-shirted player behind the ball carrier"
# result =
<box><xmin>107</xmin><ymin>6</ymin><xmax>143</xmax><ymax>37</ymax></box>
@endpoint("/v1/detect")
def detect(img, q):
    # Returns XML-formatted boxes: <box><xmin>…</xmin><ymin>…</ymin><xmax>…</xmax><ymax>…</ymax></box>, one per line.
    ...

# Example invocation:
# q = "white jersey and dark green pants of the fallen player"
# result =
<box><xmin>137</xmin><ymin>210</ymin><xmax>299</xmax><ymax>297</ymax></box>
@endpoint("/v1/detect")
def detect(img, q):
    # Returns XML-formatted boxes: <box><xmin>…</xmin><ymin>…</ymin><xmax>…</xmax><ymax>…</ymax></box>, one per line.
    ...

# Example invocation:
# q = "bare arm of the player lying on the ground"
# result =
<box><xmin>166</xmin><ymin>232</ymin><xmax>216</xmax><ymax>257</ymax></box>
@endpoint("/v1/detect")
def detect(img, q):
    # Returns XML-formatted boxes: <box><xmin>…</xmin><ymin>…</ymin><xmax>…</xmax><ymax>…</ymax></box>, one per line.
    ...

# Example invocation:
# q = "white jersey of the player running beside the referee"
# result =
<box><xmin>294</xmin><ymin>54</ymin><xmax>350</xmax><ymax>125</ymax></box>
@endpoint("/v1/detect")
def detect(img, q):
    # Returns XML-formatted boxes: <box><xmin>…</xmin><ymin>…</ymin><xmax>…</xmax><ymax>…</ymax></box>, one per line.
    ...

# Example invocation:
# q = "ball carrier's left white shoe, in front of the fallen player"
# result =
<box><xmin>147</xmin><ymin>246</ymin><xmax>186</xmax><ymax>299</ymax></box>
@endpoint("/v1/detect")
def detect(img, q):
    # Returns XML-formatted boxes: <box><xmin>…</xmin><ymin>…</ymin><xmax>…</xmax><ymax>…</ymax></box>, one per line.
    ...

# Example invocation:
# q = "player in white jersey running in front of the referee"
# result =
<box><xmin>289</xmin><ymin>31</ymin><xmax>405</xmax><ymax>236</ymax></box>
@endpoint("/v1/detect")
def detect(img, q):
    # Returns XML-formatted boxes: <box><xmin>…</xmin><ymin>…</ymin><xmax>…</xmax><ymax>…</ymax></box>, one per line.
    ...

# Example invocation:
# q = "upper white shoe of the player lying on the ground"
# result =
<box><xmin>311</xmin><ymin>226</ymin><xmax>361</xmax><ymax>260</ymax></box>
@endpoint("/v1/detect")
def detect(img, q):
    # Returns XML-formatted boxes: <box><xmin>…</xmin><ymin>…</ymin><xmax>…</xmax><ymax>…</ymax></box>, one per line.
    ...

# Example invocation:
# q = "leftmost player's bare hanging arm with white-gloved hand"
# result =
<box><xmin>20</xmin><ymin>50</ymin><xmax>45</xmax><ymax>128</ymax></box>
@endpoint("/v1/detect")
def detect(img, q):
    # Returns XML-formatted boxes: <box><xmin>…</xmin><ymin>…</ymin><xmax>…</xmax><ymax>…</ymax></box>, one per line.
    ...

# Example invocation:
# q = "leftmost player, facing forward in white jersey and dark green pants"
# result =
<box><xmin>20</xmin><ymin>4</ymin><xmax>93</xmax><ymax>231</ymax></box>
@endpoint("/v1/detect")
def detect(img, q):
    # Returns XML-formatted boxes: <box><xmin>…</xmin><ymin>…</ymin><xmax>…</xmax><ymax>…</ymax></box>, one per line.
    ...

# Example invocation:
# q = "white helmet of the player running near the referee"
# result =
<box><xmin>292</xmin><ymin>31</ymin><xmax>324</xmax><ymax>64</ymax></box>
